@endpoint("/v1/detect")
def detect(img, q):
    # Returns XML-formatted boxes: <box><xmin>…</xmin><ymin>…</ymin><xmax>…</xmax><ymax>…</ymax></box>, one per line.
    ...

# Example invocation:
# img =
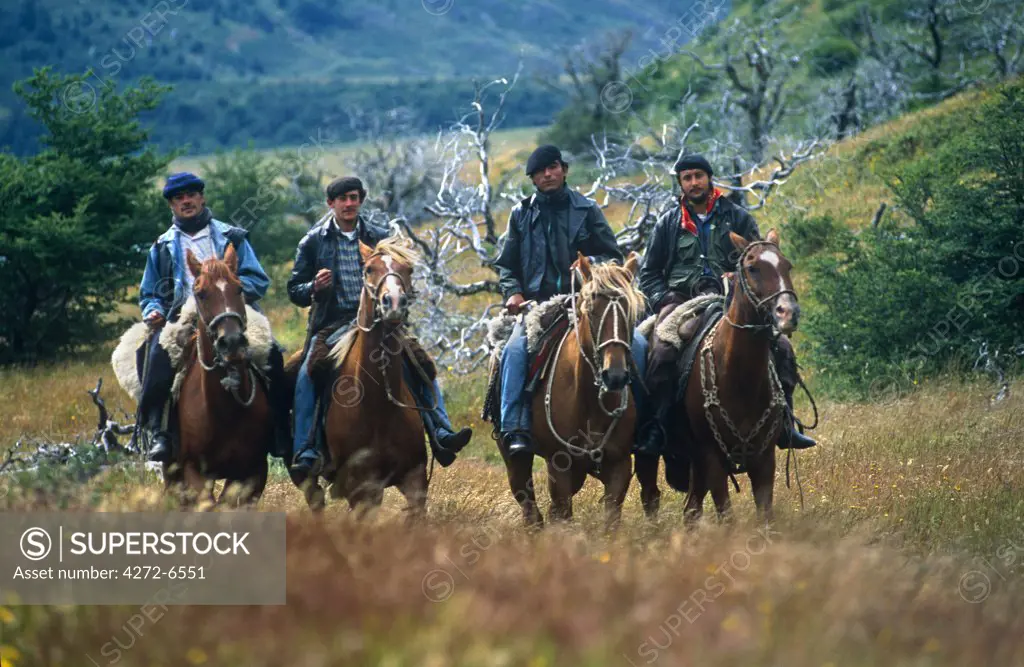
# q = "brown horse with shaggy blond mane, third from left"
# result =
<box><xmin>499</xmin><ymin>253</ymin><xmax>644</xmax><ymax>530</ymax></box>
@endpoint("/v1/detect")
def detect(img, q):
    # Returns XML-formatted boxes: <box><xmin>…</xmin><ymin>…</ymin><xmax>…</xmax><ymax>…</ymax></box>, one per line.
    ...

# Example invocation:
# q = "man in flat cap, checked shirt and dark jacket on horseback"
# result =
<box><xmin>288</xmin><ymin>176</ymin><xmax>473</xmax><ymax>481</ymax></box>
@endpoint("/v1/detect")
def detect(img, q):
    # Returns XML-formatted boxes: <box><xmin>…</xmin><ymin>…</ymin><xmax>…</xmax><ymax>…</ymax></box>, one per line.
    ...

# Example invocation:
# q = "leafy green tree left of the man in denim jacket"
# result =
<box><xmin>0</xmin><ymin>68</ymin><xmax>176</xmax><ymax>364</ymax></box>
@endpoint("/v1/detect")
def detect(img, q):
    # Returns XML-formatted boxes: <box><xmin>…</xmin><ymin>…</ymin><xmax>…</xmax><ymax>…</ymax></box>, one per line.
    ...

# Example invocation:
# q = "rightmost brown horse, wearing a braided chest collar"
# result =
<box><xmin>680</xmin><ymin>230</ymin><xmax>800</xmax><ymax>526</ymax></box>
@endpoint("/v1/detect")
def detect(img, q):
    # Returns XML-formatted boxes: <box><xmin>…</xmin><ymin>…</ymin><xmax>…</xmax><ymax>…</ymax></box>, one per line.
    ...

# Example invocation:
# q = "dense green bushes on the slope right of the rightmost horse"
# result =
<box><xmin>788</xmin><ymin>80</ymin><xmax>1024</xmax><ymax>389</ymax></box>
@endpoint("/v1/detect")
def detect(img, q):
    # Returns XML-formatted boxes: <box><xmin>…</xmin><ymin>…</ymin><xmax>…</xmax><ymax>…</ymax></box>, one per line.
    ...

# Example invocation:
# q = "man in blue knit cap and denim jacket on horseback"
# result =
<box><xmin>139</xmin><ymin>172</ymin><xmax>291</xmax><ymax>462</ymax></box>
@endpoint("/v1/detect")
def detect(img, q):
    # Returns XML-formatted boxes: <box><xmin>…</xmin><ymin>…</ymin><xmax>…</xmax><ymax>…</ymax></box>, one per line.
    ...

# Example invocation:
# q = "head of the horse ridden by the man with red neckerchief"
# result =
<box><xmin>729</xmin><ymin>230</ymin><xmax>800</xmax><ymax>336</ymax></box>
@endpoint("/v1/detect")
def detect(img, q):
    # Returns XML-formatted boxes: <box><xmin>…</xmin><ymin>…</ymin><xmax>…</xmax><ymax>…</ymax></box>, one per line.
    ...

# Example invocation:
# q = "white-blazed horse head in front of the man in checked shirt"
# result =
<box><xmin>359</xmin><ymin>239</ymin><xmax>416</xmax><ymax>327</ymax></box>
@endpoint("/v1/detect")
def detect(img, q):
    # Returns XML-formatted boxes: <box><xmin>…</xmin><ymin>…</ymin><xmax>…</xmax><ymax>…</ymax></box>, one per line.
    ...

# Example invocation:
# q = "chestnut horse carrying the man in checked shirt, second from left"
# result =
<box><xmin>301</xmin><ymin>239</ymin><xmax>427</xmax><ymax>519</ymax></box>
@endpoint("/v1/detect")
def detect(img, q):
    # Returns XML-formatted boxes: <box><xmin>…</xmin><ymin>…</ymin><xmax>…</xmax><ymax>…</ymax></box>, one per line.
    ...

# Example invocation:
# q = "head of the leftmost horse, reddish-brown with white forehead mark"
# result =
<box><xmin>185</xmin><ymin>245</ymin><xmax>249</xmax><ymax>363</ymax></box>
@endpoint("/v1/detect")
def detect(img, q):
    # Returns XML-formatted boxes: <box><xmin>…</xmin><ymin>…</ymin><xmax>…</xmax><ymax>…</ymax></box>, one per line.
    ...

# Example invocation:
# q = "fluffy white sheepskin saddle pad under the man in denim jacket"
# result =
<box><xmin>111</xmin><ymin>296</ymin><xmax>274</xmax><ymax>403</ymax></box>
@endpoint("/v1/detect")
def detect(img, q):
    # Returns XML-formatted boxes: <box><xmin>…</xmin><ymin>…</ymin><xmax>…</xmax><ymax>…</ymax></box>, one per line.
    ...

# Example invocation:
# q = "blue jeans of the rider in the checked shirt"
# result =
<box><xmin>292</xmin><ymin>345</ymin><xmax>452</xmax><ymax>460</ymax></box>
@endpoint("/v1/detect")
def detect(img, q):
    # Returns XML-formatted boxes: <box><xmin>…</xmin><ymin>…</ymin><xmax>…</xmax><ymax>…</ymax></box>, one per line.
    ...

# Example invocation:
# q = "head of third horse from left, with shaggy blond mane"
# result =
<box><xmin>572</xmin><ymin>252</ymin><xmax>644</xmax><ymax>391</ymax></box>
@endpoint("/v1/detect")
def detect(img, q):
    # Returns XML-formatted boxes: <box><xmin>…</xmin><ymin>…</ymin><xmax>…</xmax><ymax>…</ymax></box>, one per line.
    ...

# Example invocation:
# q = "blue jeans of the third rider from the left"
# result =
<box><xmin>501</xmin><ymin>322</ymin><xmax>650</xmax><ymax>433</ymax></box>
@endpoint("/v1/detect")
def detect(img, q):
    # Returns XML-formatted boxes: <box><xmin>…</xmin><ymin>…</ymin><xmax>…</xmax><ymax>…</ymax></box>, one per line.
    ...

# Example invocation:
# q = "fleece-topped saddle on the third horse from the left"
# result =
<box><xmin>480</xmin><ymin>294</ymin><xmax>573</xmax><ymax>431</ymax></box>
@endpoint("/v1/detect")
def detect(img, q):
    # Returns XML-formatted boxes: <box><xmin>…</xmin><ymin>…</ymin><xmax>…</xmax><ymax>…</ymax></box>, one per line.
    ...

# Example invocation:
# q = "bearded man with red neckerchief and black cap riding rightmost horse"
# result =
<box><xmin>638</xmin><ymin>155</ymin><xmax>817</xmax><ymax>455</ymax></box>
